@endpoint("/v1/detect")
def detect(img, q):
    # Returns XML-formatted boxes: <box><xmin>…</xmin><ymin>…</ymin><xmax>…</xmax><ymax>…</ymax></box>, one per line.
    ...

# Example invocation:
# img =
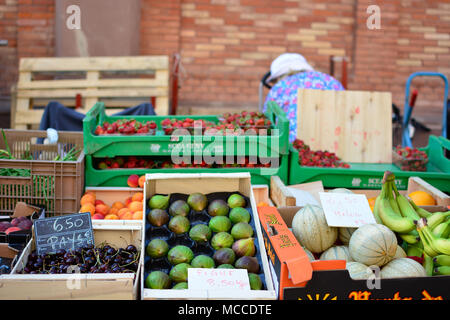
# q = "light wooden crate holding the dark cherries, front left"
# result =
<box><xmin>0</xmin><ymin>222</ymin><xmax>143</xmax><ymax>300</ymax></box>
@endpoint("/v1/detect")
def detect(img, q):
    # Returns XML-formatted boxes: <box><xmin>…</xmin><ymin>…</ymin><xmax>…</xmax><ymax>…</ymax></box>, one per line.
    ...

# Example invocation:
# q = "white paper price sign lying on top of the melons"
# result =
<box><xmin>319</xmin><ymin>192</ymin><xmax>376</xmax><ymax>228</ymax></box>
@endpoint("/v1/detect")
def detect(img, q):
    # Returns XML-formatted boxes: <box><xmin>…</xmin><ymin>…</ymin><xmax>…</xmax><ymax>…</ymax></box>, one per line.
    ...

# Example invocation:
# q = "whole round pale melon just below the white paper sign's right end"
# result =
<box><xmin>349</xmin><ymin>223</ymin><xmax>397</xmax><ymax>267</ymax></box>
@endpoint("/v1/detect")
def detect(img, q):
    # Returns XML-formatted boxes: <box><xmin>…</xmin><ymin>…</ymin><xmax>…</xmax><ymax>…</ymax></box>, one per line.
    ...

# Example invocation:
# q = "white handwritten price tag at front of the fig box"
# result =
<box><xmin>188</xmin><ymin>268</ymin><xmax>250</xmax><ymax>291</ymax></box>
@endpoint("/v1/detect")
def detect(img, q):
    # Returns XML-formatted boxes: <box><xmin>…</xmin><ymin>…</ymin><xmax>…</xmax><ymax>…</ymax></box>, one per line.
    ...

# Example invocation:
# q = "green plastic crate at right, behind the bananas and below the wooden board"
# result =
<box><xmin>289</xmin><ymin>136</ymin><xmax>450</xmax><ymax>192</ymax></box>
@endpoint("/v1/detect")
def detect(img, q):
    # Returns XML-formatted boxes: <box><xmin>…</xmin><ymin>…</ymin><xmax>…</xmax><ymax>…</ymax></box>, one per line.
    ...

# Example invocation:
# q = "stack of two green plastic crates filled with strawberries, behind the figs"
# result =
<box><xmin>83</xmin><ymin>103</ymin><xmax>289</xmax><ymax>187</ymax></box>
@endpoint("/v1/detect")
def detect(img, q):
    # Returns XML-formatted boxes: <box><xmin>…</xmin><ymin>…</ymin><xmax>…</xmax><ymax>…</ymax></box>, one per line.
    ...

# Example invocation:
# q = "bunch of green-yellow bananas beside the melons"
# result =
<box><xmin>373</xmin><ymin>171</ymin><xmax>450</xmax><ymax>276</ymax></box>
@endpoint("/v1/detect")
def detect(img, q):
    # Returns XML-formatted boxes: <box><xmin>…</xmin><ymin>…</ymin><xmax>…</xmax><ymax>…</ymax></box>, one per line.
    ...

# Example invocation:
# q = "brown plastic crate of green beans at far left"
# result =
<box><xmin>0</xmin><ymin>129</ymin><xmax>85</xmax><ymax>216</ymax></box>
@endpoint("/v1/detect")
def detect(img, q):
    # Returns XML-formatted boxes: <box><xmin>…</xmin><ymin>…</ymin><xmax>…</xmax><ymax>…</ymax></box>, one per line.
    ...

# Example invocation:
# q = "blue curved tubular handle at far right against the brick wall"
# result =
<box><xmin>402</xmin><ymin>71</ymin><xmax>448</xmax><ymax>147</ymax></box>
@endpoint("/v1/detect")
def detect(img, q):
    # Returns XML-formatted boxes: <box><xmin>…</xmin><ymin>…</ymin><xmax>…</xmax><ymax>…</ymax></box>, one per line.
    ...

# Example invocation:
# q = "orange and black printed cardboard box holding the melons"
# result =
<box><xmin>264</xmin><ymin>207</ymin><xmax>450</xmax><ymax>300</ymax></box>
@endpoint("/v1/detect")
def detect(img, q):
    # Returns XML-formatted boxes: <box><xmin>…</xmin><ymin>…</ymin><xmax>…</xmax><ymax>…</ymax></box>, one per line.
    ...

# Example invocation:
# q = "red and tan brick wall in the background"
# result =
<box><xmin>0</xmin><ymin>0</ymin><xmax>450</xmax><ymax>125</ymax></box>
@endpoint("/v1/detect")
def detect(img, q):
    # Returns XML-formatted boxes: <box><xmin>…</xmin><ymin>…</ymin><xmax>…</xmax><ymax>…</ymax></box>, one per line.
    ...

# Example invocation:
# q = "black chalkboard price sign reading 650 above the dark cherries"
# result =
<box><xmin>34</xmin><ymin>212</ymin><xmax>94</xmax><ymax>254</ymax></box>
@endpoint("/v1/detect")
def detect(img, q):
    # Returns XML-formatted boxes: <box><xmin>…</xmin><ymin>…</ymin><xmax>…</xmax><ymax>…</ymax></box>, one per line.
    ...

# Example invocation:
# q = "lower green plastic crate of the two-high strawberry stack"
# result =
<box><xmin>85</xmin><ymin>155</ymin><xmax>289</xmax><ymax>187</ymax></box>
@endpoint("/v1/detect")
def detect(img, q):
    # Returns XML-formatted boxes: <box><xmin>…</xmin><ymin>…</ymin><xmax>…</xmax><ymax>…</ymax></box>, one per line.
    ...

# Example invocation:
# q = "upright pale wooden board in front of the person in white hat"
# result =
<box><xmin>297</xmin><ymin>89</ymin><xmax>392</xmax><ymax>163</ymax></box>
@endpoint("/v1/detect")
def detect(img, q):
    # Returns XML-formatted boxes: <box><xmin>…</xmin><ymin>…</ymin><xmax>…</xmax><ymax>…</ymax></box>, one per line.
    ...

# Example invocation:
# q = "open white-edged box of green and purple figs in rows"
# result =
<box><xmin>141</xmin><ymin>173</ymin><xmax>275</xmax><ymax>299</ymax></box>
